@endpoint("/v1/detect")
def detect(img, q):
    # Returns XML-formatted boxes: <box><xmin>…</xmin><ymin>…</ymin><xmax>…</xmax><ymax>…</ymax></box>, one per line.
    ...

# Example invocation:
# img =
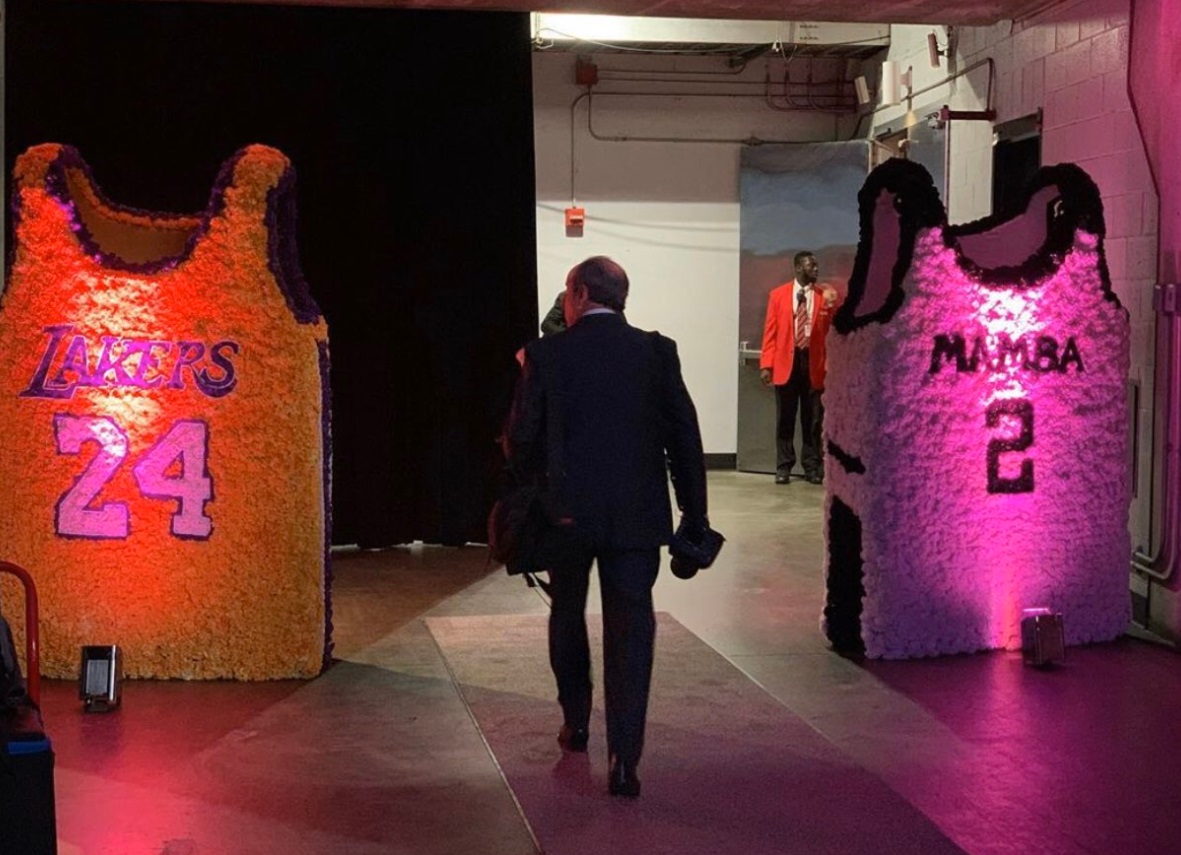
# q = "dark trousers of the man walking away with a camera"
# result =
<box><xmin>549</xmin><ymin>548</ymin><xmax>660</xmax><ymax>763</ymax></box>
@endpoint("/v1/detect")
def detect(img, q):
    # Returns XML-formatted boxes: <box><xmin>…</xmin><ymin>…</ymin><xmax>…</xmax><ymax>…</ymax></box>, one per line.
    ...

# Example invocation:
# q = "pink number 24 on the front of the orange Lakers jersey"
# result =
<box><xmin>53</xmin><ymin>413</ymin><xmax>214</xmax><ymax>540</ymax></box>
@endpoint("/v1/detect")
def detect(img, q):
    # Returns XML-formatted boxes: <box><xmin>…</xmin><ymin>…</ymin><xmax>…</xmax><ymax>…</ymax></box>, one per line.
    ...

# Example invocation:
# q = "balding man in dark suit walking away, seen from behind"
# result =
<box><xmin>507</xmin><ymin>256</ymin><xmax>709</xmax><ymax>796</ymax></box>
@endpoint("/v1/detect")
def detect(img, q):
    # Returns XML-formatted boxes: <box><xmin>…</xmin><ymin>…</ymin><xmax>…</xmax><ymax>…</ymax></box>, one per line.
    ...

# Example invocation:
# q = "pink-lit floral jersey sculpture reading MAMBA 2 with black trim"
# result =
<box><xmin>823</xmin><ymin>159</ymin><xmax>1130</xmax><ymax>658</ymax></box>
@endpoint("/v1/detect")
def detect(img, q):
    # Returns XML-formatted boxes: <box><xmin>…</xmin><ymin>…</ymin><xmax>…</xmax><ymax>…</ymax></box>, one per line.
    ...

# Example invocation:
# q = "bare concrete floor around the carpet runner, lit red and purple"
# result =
<box><xmin>34</xmin><ymin>472</ymin><xmax>1181</xmax><ymax>855</ymax></box>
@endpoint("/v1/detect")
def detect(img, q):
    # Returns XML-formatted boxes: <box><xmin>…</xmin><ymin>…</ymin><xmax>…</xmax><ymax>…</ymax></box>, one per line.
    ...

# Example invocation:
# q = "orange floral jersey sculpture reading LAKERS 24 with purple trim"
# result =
<box><xmin>0</xmin><ymin>144</ymin><xmax>331</xmax><ymax>680</ymax></box>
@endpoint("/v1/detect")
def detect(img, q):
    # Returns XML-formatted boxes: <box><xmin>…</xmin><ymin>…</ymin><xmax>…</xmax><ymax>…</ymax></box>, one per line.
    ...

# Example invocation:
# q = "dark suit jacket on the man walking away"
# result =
<box><xmin>507</xmin><ymin>314</ymin><xmax>706</xmax><ymax>549</ymax></box>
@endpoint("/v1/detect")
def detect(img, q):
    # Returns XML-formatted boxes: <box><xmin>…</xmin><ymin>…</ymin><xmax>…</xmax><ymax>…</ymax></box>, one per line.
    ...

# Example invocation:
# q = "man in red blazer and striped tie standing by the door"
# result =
<box><xmin>759</xmin><ymin>250</ymin><xmax>836</xmax><ymax>484</ymax></box>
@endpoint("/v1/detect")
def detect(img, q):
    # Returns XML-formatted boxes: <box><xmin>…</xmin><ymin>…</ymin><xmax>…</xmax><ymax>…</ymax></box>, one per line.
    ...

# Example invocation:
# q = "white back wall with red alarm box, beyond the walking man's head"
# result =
<box><xmin>534</xmin><ymin>53</ymin><xmax>839</xmax><ymax>453</ymax></box>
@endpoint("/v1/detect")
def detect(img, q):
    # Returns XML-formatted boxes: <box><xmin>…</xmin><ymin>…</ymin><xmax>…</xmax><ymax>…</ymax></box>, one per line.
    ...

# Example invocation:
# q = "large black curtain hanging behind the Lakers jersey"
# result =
<box><xmin>5</xmin><ymin>0</ymin><xmax>537</xmax><ymax>547</ymax></box>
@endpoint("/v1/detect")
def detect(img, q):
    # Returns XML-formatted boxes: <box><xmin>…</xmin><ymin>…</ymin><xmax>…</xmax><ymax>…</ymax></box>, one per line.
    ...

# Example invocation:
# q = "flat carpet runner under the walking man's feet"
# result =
<box><xmin>426</xmin><ymin>613</ymin><xmax>961</xmax><ymax>855</ymax></box>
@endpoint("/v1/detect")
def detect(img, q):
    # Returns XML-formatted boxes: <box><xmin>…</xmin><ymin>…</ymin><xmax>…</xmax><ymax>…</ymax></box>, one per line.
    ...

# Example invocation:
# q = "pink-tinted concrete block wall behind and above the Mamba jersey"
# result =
<box><xmin>952</xmin><ymin>0</ymin><xmax>1157</xmax><ymax>547</ymax></box>
